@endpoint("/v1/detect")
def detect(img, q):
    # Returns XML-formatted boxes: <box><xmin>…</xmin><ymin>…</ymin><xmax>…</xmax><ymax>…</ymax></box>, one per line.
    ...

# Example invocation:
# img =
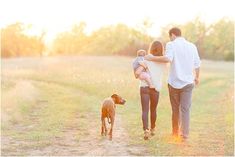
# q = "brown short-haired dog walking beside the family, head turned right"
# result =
<box><xmin>101</xmin><ymin>94</ymin><xmax>126</xmax><ymax>140</ymax></box>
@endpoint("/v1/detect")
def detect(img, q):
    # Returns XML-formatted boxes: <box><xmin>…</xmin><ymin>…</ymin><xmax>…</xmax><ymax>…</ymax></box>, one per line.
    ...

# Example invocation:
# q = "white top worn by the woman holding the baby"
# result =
<box><xmin>140</xmin><ymin>60</ymin><xmax>166</xmax><ymax>92</ymax></box>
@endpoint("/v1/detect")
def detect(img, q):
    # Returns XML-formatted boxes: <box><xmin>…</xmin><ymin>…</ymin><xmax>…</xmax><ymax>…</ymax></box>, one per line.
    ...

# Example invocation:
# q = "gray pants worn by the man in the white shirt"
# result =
<box><xmin>168</xmin><ymin>84</ymin><xmax>194</xmax><ymax>138</ymax></box>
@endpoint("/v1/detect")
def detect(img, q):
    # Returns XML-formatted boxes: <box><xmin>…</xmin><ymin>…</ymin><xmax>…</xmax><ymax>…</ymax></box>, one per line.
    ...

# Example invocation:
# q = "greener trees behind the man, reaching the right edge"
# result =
<box><xmin>160</xmin><ymin>18</ymin><xmax>234</xmax><ymax>61</ymax></box>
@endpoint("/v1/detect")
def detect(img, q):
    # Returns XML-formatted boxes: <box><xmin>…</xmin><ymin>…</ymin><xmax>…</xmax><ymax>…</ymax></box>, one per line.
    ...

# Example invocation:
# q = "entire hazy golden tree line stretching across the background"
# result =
<box><xmin>1</xmin><ymin>18</ymin><xmax>234</xmax><ymax>60</ymax></box>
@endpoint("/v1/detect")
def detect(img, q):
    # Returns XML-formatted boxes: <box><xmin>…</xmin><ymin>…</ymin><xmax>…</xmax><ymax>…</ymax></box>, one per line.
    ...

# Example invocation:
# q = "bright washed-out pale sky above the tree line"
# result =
<box><xmin>0</xmin><ymin>0</ymin><xmax>234</xmax><ymax>40</ymax></box>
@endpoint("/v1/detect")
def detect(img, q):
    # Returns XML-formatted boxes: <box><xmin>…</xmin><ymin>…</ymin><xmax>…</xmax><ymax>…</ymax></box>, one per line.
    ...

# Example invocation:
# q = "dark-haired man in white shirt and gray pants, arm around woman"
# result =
<box><xmin>145</xmin><ymin>28</ymin><xmax>200</xmax><ymax>140</ymax></box>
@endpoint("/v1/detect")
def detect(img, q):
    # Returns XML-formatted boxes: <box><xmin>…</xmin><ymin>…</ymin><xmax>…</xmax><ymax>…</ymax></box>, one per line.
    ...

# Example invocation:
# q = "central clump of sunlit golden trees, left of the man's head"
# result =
<box><xmin>53</xmin><ymin>24</ymin><xmax>152</xmax><ymax>55</ymax></box>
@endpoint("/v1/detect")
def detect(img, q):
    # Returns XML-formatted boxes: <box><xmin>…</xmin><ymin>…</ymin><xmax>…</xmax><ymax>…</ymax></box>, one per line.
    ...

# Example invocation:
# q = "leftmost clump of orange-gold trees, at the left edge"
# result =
<box><xmin>1</xmin><ymin>23</ymin><xmax>45</xmax><ymax>57</ymax></box>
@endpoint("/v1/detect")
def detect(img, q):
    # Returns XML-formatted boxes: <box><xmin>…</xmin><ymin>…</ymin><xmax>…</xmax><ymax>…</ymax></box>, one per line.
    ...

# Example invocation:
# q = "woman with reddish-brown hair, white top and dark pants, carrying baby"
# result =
<box><xmin>140</xmin><ymin>41</ymin><xmax>166</xmax><ymax>140</ymax></box>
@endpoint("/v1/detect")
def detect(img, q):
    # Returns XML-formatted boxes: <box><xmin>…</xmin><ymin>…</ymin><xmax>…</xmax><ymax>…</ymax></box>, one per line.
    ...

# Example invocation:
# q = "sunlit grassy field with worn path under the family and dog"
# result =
<box><xmin>1</xmin><ymin>56</ymin><xmax>234</xmax><ymax>156</ymax></box>
